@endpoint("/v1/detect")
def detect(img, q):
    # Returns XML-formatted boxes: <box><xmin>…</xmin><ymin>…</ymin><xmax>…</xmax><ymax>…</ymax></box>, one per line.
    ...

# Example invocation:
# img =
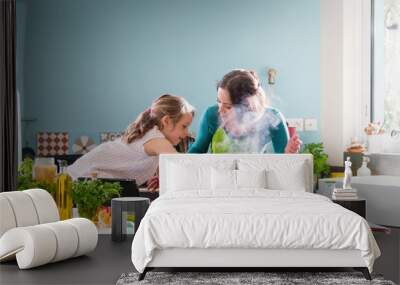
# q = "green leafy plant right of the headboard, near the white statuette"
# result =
<box><xmin>303</xmin><ymin>143</ymin><xmax>330</xmax><ymax>189</ymax></box>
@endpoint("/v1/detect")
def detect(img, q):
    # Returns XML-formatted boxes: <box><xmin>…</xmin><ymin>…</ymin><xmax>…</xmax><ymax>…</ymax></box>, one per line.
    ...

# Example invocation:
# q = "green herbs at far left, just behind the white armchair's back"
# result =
<box><xmin>18</xmin><ymin>158</ymin><xmax>56</xmax><ymax>195</ymax></box>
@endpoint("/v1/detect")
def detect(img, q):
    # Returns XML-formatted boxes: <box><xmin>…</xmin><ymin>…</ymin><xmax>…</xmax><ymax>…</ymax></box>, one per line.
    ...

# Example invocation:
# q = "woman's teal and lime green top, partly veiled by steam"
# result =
<box><xmin>189</xmin><ymin>105</ymin><xmax>289</xmax><ymax>153</ymax></box>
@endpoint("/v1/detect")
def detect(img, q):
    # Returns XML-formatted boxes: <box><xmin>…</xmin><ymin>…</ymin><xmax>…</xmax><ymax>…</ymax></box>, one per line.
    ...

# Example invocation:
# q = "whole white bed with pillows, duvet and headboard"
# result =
<box><xmin>132</xmin><ymin>154</ymin><xmax>380</xmax><ymax>279</ymax></box>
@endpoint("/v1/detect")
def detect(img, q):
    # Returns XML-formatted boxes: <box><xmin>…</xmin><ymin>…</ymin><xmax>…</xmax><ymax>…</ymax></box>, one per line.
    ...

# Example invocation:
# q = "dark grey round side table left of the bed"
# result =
<box><xmin>111</xmin><ymin>197</ymin><xmax>150</xmax><ymax>241</ymax></box>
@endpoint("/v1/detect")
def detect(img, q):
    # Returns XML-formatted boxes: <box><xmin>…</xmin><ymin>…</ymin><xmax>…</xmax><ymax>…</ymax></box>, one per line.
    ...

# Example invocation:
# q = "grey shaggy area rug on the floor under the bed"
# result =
<box><xmin>117</xmin><ymin>272</ymin><xmax>395</xmax><ymax>285</ymax></box>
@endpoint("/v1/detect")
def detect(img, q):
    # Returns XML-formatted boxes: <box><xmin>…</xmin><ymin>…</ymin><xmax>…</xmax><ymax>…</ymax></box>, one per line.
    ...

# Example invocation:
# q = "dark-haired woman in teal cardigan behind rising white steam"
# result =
<box><xmin>189</xmin><ymin>69</ymin><xmax>301</xmax><ymax>153</ymax></box>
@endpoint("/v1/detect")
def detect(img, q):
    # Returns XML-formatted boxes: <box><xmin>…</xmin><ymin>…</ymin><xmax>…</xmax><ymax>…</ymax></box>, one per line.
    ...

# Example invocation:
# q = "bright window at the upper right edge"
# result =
<box><xmin>372</xmin><ymin>0</ymin><xmax>400</xmax><ymax>130</ymax></box>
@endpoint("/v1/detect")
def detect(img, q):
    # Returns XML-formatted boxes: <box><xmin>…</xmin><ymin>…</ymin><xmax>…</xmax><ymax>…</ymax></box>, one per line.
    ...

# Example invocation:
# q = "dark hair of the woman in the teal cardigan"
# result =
<box><xmin>217</xmin><ymin>69</ymin><xmax>268</xmax><ymax>112</ymax></box>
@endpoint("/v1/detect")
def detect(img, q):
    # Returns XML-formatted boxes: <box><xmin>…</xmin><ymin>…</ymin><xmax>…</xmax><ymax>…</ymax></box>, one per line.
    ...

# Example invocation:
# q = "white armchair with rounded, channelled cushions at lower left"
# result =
<box><xmin>0</xmin><ymin>189</ymin><xmax>98</xmax><ymax>269</ymax></box>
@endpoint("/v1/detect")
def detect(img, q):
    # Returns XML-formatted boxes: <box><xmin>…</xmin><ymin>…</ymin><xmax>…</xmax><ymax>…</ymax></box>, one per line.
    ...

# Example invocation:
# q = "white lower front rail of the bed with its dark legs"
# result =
<box><xmin>139</xmin><ymin>248</ymin><xmax>371</xmax><ymax>281</ymax></box>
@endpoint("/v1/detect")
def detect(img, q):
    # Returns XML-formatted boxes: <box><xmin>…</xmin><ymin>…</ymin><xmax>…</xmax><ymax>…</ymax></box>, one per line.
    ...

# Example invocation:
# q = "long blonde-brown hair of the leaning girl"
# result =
<box><xmin>122</xmin><ymin>94</ymin><xmax>195</xmax><ymax>144</ymax></box>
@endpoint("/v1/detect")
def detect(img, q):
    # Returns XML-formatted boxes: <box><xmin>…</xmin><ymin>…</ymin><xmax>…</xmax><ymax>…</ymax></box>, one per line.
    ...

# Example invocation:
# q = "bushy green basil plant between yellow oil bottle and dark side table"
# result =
<box><xmin>72</xmin><ymin>180</ymin><xmax>122</xmax><ymax>220</ymax></box>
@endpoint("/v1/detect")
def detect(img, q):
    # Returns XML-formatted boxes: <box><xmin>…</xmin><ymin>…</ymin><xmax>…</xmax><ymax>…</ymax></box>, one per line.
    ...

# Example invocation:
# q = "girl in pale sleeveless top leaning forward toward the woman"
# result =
<box><xmin>68</xmin><ymin>94</ymin><xmax>194</xmax><ymax>188</ymax></box>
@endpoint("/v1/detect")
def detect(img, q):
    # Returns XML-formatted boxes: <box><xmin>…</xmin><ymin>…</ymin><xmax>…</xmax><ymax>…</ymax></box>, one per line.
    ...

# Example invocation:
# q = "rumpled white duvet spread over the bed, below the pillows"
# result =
<box><xmin>132</xmin><ymin>189</ymin><xmax>380</xmax><ymax>272</ymax></box>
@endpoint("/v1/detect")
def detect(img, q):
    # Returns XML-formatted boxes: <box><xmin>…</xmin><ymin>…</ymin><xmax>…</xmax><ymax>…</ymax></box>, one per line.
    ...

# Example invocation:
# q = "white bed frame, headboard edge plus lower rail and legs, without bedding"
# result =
<box><xmin>139</xmin><ymin>154</ymin><xmax>371</xmax><ymax>280</ymax></box>
